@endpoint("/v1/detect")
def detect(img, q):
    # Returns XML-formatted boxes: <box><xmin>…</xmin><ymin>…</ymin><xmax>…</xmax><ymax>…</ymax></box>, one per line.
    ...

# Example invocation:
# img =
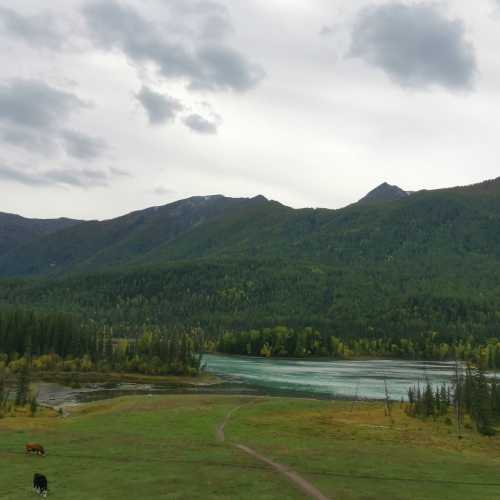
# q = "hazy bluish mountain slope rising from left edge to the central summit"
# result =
<box><xmin>0</xmin><ymin>195</ymin><xmax>276</xmax><ymax>276</ymax></box>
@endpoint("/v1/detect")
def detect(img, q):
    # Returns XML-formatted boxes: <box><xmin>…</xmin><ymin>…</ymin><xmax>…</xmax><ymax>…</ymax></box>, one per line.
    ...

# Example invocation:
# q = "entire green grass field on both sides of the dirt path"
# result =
<box><xmin>0</xmin><ymin>395</ymin><xmax>500</xmax><ymax>500</ymax></box>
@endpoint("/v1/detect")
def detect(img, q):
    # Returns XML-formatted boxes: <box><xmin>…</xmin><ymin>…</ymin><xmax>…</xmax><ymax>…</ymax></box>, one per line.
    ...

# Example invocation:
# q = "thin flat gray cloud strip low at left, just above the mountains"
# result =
<box><xmin>0</xmin><ymin>164</ymin><xmax>116</xmax><ymax>188</ymax></box>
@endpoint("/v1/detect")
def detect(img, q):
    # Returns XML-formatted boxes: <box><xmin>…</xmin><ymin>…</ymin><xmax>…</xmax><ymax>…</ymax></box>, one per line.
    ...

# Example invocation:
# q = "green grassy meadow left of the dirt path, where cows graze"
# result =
<box><xmin>0</xmin><ymin>397</ymin><xmax>300</xmax><ymax>500</ymax></box>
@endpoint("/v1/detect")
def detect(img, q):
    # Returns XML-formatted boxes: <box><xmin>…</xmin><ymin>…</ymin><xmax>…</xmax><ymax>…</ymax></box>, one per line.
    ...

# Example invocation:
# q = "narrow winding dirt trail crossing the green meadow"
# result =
<box><xmin>215</xmin><ymin>400</ymin><xmax>331</xmax><ymax>500</ymax></box>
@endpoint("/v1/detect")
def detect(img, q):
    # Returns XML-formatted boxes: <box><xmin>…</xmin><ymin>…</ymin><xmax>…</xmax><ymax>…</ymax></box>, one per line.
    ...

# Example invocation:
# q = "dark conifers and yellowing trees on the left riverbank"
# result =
<box><xmin>0</xmin><ymin>309</ymin><xmax>204</xmax><ymax>375</ymax></box>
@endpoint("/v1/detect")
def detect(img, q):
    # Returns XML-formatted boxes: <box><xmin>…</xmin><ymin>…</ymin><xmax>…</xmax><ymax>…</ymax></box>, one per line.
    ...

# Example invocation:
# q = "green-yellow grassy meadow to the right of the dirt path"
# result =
<box><xmin>229</xmin><ymin>400</ymin><xmax>500</xmax><ymax>500</ymax></box>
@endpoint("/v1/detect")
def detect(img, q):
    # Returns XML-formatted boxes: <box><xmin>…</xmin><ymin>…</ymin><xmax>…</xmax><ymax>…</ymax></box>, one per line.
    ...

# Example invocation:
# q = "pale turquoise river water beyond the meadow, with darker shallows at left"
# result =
<box><xmin>33</xmin><ymin>354</ymin><xmax>460</xmax><ymax>407</ymax></box>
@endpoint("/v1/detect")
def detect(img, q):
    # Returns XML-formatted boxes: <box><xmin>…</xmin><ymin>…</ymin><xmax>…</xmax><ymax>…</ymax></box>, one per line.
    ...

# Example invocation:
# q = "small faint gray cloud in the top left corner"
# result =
<box><xmin>0</xmin><ymin>7</ymin><xmax>65</xmax><ymax>49</ymax></box>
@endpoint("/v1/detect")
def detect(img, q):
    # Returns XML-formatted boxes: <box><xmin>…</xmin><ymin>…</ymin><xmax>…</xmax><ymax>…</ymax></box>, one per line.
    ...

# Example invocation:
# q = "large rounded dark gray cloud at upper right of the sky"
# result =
<box><xmin>350</xmin><ymin>2</ymin><xmax>476</xmax><ymax>89</ymax></box>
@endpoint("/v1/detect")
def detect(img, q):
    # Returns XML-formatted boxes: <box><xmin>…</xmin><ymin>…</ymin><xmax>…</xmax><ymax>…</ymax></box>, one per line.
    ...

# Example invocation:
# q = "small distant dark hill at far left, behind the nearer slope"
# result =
<box><xmin>0</xmin><ymin>212</ymin><xmax>81</xmax><ymax>255</ymax></box>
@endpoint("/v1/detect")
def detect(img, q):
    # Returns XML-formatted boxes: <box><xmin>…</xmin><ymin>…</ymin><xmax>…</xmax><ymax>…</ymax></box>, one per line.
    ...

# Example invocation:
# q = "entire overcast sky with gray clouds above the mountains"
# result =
<box><xmin>0</xmin><ymin>0</ymin><xmax>500</xmax><ymax>219</ymax></box>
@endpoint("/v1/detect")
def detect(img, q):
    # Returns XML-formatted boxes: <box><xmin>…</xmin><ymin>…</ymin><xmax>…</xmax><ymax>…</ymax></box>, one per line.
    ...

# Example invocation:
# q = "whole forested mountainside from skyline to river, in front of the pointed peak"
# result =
<box><xmin>0</xmin><ymin>179</ymin><xmax>500</xmax><ymax>364</ymax></box>
